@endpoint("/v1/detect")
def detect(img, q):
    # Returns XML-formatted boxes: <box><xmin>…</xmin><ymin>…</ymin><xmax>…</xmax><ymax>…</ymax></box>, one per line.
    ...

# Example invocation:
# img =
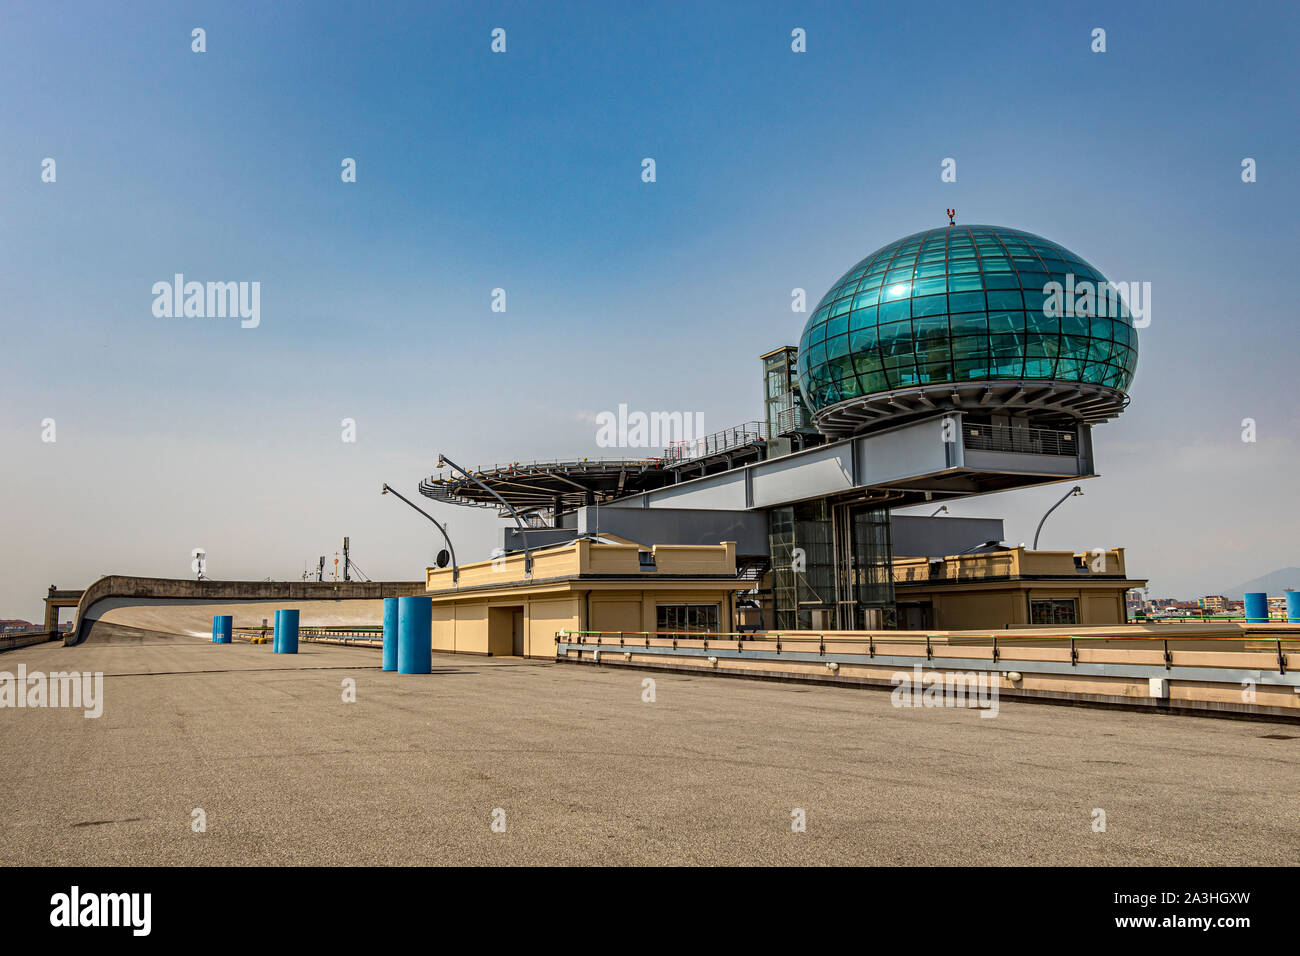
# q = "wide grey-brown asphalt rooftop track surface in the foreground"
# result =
<box><xmin>0</xmin><ymin>628</ymin><xmax>1300</xmax><ymax>866</ymax></box>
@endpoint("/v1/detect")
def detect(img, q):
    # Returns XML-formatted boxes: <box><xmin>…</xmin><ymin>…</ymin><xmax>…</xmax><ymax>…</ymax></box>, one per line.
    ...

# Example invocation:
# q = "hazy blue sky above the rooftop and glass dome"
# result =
<box><xmin>0</xmin><ymin>0</ymin><xmax>1300</xmax><ymax>622</ymax></box>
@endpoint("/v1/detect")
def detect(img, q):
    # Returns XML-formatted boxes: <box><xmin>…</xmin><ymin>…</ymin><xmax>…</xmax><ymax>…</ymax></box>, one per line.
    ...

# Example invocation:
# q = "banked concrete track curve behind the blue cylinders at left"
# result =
<box><xmin>64</xmin><ymin>575</ymin><xmax>425</xmax><ymax>646</ymax></box>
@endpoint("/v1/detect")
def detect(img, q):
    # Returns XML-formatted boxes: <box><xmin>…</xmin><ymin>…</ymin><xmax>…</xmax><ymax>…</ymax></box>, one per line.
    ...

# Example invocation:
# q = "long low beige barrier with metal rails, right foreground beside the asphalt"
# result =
<box><xmin>555</xmin><ymin>631</ymin><xmax>1300</xmax><ymax>719</ymax></box>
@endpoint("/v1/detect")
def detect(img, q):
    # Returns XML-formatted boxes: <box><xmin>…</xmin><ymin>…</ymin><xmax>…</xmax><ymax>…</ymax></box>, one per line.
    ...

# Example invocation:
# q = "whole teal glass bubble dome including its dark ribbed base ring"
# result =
<box><xmin>798</xmin><ymin>225</ymin><xmax>1138</xmax><ymax>434</ymax></box>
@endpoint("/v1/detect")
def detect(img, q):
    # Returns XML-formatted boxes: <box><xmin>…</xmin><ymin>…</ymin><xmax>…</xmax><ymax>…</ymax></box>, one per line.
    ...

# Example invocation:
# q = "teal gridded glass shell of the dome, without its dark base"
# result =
<box><xmin>800</xmin><ymin>225</ymin><xmax>1138</xmax><ymax>410</ymax></box>
